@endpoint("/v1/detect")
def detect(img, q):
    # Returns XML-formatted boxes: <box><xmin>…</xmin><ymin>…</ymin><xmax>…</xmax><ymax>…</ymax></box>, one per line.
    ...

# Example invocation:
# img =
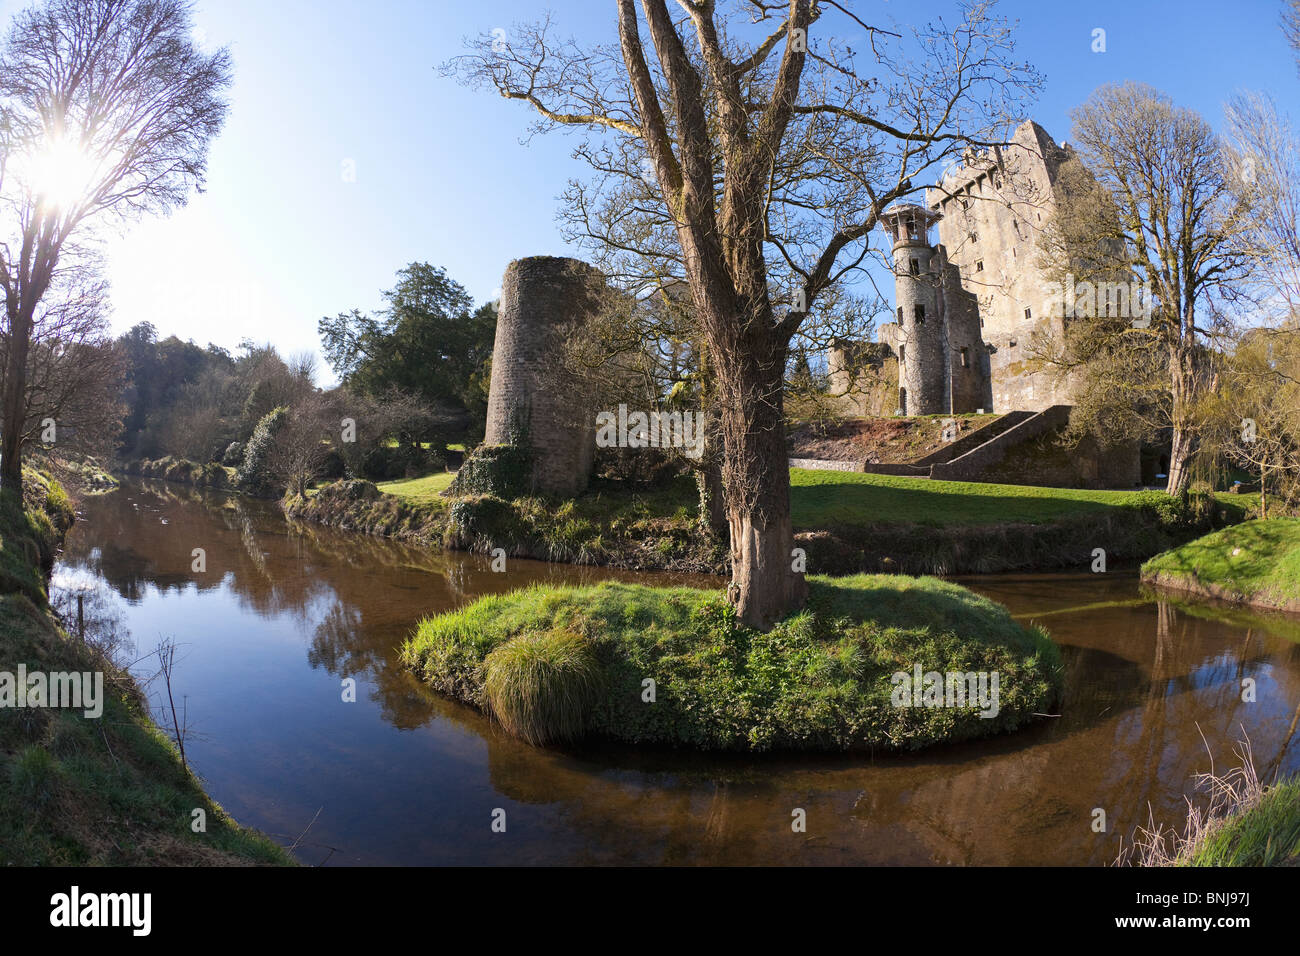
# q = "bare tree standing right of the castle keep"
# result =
<box><xmin>1054</xmin><ymin>83</ymin><xmax>1252</xmax><ymax>494</ymax></box>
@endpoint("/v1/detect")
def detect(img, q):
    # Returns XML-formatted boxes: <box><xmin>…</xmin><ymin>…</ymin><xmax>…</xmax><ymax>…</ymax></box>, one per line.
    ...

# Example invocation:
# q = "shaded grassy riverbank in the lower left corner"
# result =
<box><xmin>0</xmin><ymin>475</ymin><xmax>293</xmax><ymax>865</ymax></box>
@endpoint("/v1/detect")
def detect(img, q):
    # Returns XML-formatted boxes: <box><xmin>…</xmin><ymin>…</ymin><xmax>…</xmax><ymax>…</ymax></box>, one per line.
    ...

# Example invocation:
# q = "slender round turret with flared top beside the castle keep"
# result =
<box><xmin>880</xmin><ymin>204</ymin><xmax>948</xmax><ymax>415</ymax></box>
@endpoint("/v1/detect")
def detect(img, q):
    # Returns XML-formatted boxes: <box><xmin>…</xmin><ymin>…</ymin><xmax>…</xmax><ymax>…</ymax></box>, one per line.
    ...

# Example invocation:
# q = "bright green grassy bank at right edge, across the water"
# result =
<box><xmin>1141</xmin><ymin>518</ymin><xmax>1300</xmax><ymax>613</ymax></box>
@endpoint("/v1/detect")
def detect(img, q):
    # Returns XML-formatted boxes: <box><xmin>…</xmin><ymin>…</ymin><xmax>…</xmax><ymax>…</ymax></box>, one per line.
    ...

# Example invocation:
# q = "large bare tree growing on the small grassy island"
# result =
<box><xmin>449</xmin><ymin>0</ymin><xmax>1036</xmax><ymax>628</ymax></box>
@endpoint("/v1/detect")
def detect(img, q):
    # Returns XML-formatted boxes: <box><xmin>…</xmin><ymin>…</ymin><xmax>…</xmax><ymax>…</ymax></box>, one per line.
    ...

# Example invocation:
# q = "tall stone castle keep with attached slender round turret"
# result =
<box><xmin>829</xmin><ymin>121</ymin><xmax>1074</xmax><ymax>415</ymax></box>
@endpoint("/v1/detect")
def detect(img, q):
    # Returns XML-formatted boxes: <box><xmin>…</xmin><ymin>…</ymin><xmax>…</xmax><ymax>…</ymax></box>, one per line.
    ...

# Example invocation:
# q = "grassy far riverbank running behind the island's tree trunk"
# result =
<box><xmin>285</xmin><ymin>470</ymin><xmax>1248</xmax><ymax>575</ymax></box>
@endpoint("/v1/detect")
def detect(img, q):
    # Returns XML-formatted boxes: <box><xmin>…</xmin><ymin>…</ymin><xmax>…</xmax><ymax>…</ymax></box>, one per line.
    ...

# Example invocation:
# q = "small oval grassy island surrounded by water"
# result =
<box><xmin>403</xmin><ymin>575</ymin><xmax>1061</xmax><ymax>750</ymax></box>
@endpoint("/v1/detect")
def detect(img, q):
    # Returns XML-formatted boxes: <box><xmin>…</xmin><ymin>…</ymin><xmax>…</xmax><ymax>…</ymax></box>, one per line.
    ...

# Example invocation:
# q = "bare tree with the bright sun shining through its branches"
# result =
<box><xmin>0</xmin><ymin>0</ymin><xmax>230</xmax><ymax>490</ymax></box>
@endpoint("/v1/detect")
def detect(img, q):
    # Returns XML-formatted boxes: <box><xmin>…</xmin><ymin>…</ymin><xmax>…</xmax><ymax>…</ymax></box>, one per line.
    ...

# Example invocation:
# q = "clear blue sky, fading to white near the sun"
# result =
<box><xmin>0</xmin><ymin>0</ymin><xmax>1300</xmax><ymax>377</ymax></box>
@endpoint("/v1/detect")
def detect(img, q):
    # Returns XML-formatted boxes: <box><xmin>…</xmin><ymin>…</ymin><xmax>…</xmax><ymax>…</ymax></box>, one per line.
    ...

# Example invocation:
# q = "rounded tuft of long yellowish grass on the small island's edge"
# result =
<box><xmin>484</xmin><ymin>630</ymin><xmax>601</xmax><ymax>744</ymax></box>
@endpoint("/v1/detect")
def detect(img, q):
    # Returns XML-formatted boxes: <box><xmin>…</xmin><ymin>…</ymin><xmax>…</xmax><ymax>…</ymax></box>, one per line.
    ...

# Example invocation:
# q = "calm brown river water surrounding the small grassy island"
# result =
<box><xmin>55</xmin><ymin>483</ymin><xmax>1300</xmax><ymax>866</ymax></box>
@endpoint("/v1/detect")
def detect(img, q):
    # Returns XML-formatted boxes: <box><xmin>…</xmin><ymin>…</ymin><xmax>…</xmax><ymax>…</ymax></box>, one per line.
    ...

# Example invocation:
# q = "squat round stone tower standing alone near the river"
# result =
<box><xmin>484</xmin><ymin>256</ymin><xmax>606</xmax><ymax>496</ymax></box>
